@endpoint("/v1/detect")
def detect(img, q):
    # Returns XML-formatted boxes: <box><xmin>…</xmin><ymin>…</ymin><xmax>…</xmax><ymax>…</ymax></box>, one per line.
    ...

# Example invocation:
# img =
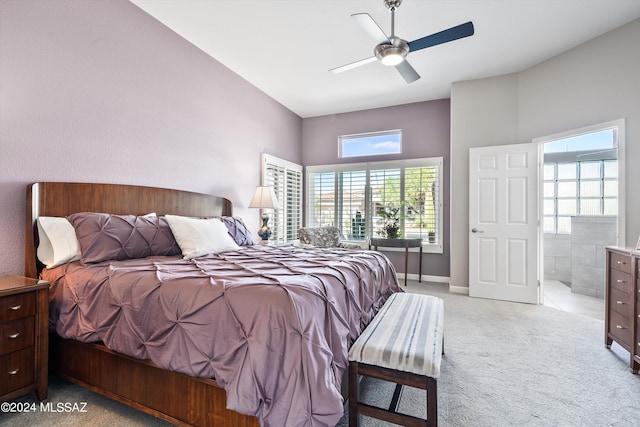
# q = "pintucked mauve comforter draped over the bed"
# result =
<box><xmin>42</xmin><ymin>245</ymin><xmax>402</xmax><ymax>426</ymax></box>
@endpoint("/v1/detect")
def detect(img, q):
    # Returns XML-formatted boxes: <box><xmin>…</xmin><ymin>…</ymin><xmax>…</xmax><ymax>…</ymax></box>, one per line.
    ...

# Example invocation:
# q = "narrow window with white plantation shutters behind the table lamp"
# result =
<box><xmin>262</xmin><ymin>154</ymin><xmax>302</xmax><ymax>242</ymax></box>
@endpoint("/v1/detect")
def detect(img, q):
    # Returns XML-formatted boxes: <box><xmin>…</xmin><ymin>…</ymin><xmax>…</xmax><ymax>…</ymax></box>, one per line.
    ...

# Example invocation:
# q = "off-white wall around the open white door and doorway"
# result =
<box><xmin>451</xmin><ymin>19</ymin><xmax>640</xmax><ymax>291</ymax></box>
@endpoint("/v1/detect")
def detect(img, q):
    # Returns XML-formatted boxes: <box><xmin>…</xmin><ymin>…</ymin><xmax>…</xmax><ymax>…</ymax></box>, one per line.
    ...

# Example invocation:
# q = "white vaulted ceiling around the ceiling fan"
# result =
<box><xmin>131</xmin><ymin>0</ymin><xmax>640</xmax><ymax>117</ymax></box>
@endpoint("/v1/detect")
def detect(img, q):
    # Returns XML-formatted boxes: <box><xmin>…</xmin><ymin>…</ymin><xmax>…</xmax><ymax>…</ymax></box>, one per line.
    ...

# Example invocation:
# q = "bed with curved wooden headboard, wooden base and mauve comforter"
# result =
<box><xmin>25</xmin><ymin>182</ymin><xmax>402</xmax><ymax>426</ymax></box>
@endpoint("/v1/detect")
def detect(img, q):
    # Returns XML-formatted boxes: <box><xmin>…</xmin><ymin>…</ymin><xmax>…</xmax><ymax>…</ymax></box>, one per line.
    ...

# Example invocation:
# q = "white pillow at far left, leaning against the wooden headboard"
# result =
<box><xmin>36</xmin><ymin>216</ymin><xmax>81</xmax><ymax>268</ymax></box>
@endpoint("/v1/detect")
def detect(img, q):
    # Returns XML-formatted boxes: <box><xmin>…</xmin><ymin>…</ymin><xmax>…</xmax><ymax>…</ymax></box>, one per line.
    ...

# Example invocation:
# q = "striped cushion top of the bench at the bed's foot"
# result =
<box><xmin>349</xmin><ymin>293</ymin><xmax>444</xmax><ymax>378</ymax></box>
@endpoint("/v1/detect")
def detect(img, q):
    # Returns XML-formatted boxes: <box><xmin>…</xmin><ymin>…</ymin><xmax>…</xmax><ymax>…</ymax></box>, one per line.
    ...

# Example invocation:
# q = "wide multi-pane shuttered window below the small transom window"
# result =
<box><xmin>307</xmin><ymin>157</ymin><xmax>442</xmax><ymax>252</ymax></box>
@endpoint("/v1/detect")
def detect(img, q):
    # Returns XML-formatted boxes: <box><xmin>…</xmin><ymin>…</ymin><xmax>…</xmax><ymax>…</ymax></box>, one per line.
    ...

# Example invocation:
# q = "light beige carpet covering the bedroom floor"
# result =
<box><xmin>0</xmin><ymin>282</ymin><xmax>640</xmax><ymax>427</ymax></box>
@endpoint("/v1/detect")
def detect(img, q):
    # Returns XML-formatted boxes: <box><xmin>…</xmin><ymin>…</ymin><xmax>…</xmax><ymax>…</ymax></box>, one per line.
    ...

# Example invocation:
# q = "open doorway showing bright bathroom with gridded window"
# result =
<box><xmin>534</xmin><ymin>119</ymin><xmax>625</xmax><ymax>301</ymax></box>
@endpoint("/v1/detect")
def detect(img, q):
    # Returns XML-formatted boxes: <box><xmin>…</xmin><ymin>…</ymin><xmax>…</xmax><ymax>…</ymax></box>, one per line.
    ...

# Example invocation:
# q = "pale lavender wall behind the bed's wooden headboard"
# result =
<box><xmin>0</xmin><ymin>0</ymin><xmax>302</xmax><ymax>274</ymax></box>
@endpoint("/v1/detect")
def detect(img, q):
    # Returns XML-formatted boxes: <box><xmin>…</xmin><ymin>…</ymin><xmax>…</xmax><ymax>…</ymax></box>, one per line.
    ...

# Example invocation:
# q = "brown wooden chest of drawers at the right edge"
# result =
<box><xmin>605</xmin><ymin>247</ymin><xmax>640</xmax><ymax>373</ymax></box>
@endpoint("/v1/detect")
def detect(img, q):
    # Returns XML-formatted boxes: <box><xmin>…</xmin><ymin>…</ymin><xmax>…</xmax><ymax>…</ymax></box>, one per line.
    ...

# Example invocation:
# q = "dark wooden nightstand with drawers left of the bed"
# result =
<box><xmin>0</xmin><ymin>276</ymin><xmax>49</xmax><ymax>402</ymax></box>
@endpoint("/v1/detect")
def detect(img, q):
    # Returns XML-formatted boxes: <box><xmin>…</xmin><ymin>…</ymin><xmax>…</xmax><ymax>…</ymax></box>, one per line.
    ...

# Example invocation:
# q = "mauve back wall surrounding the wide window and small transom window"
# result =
<box><xmin>302</xmin><ymin>99</ymin><xmax>450</xmax><ymax>278</ymax></box>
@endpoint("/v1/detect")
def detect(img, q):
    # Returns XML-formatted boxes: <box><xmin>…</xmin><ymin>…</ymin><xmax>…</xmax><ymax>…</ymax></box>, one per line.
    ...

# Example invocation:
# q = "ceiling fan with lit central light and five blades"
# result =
<box><xmin>329</xmin><ymin>0</ymin><xmax>474</xmax><ymax>83</ymax></box>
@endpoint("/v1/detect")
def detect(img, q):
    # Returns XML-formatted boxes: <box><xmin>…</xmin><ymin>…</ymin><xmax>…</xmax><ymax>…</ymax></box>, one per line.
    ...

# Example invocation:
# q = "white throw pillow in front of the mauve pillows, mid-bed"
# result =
<box><xmin>165</xmin><ymin>215</ymin><xmax>240</xmax><ymax>259</ymax></box>
